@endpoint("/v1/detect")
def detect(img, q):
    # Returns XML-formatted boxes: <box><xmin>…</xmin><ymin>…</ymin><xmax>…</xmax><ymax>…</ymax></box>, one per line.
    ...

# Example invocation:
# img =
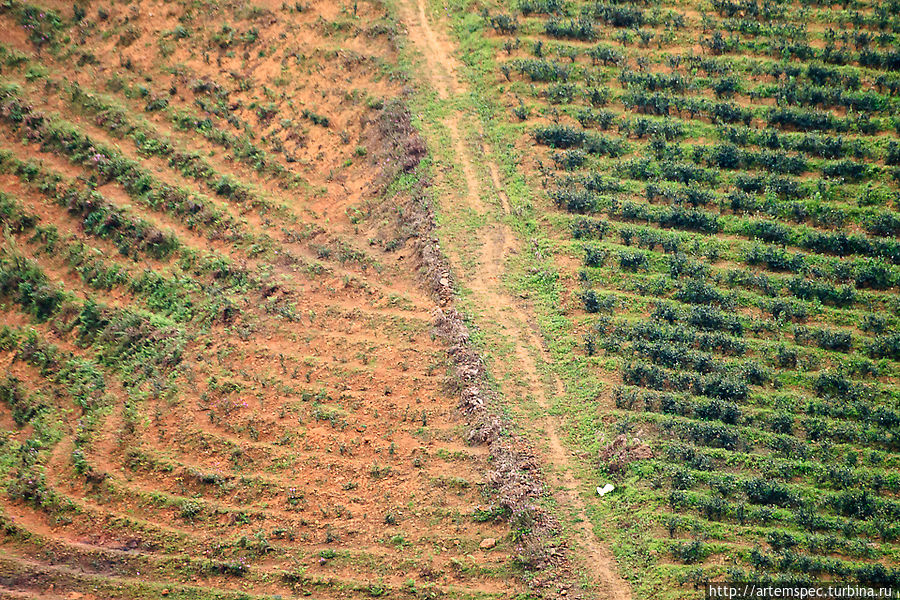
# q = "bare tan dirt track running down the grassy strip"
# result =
<box><xmin>400</xmin><ymin>0</ymin><xmax>631</xmax><ymax>600</ymax></box>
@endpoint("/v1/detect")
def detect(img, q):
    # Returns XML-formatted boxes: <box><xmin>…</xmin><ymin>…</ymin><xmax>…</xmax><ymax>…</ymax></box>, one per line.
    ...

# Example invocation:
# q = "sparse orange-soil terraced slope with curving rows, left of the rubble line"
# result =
<box><xmin>0</xmin><ymin>0</ymin><xmax>536</xmax><ymax>598</ymax></box>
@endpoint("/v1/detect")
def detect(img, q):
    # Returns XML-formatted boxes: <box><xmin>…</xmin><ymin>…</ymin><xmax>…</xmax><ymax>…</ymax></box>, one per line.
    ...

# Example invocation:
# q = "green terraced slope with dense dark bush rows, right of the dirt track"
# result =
<box><xmin>431</xmin><ymin>0</ymin><xmax>900</xmax><ymax>598</ymax></box>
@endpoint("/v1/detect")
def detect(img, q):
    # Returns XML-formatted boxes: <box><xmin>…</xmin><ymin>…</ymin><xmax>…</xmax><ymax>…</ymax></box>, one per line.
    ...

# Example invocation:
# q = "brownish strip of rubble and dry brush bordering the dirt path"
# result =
<box><xmin>376</xmin><ymin>101</ymin><xmax>577</xmax><ymax>597</ymax></box>
